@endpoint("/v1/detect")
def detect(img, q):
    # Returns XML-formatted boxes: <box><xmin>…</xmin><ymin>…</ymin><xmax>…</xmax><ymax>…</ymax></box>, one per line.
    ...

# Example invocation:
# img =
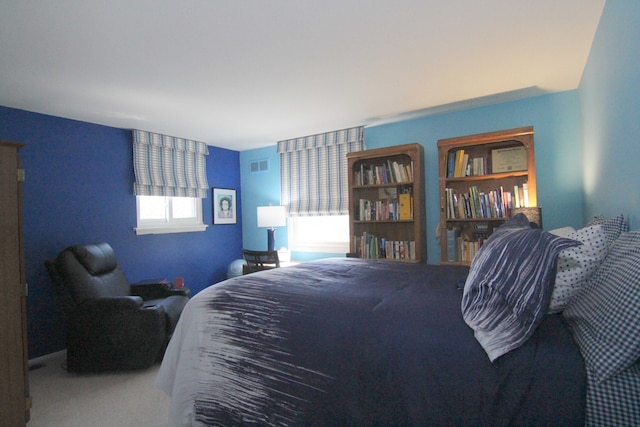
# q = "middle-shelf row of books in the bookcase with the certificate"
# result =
<box><xmin>445</xmin><ymin>182</ymin><xmax>529</xmax><ymax>219</ymax></box>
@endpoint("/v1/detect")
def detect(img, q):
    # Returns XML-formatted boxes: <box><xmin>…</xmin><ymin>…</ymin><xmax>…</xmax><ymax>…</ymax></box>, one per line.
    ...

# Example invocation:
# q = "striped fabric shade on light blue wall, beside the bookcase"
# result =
<box><xmin>278</xmin><ymin>126</ymin><xmax>364</xmax><ymax>216</ymax></box>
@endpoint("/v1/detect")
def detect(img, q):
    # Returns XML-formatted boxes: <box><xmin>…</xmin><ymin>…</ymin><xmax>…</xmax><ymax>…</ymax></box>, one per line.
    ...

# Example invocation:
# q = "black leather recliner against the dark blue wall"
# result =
<box><xmin>45</xmin><ymin>243</ymin><xmax>189</xmax><ymax>372</ymax></box>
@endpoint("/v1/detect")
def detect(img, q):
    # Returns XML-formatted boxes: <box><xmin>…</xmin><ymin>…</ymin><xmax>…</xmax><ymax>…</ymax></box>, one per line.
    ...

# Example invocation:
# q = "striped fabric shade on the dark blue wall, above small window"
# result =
<box><xmin>133</xmin><ymin>130</ymin><xmax>209</xmax><ymax>198</ymax></box>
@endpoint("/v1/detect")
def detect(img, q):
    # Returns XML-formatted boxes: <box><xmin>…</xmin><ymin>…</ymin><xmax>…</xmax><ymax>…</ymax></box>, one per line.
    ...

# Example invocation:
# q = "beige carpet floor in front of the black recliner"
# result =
<box><xmin>27</xmin><ymin>352</ymin><xmax>169</xmax><ymax>427</ymax></box>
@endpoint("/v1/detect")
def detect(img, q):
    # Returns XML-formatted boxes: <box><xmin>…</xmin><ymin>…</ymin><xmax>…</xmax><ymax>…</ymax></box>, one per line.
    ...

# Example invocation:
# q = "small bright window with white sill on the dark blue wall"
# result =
<box><xmin>136</xmin><ymin>196</ymin><xmax>207</xmax><ymax>234</ymax></box>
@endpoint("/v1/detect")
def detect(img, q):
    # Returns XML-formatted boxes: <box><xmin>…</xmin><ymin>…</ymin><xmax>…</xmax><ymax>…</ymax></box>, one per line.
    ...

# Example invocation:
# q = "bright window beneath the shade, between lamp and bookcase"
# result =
<box><xmin>287</xmin><ymin>215</ymin><xmax>349</xmax><ymax>253</ymax></box>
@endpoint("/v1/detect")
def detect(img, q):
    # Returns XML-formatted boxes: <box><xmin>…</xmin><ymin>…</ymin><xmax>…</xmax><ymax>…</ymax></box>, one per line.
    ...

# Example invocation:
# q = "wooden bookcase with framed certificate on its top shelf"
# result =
<box><xmin>438</xmin><ymin>126</ymin><xmax>537</xmax><ymax>264</ymax></box>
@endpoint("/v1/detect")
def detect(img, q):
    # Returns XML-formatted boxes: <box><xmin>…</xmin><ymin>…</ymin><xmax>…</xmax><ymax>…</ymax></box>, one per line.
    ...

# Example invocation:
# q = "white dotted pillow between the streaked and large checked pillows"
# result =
<box><xmin>549</xmin><ymin>224</ymin><xmax>608</xmax><ymax>313</ymax></box>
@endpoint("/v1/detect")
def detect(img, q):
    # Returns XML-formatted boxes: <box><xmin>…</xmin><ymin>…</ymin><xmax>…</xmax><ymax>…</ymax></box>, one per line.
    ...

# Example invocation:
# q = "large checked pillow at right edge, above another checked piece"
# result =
<box><xmin>562</xmin><ymin>231</ymin><xmax>640</xmax><ymax>383</ymax></box>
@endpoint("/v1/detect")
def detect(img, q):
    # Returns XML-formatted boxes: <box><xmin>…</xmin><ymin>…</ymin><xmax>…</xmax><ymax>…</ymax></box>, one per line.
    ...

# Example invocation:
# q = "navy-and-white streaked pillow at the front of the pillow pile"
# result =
<box><xmin>462</xmin><ymin>217</ymin><xmax>580</xmax><ymax>362</ymax></box>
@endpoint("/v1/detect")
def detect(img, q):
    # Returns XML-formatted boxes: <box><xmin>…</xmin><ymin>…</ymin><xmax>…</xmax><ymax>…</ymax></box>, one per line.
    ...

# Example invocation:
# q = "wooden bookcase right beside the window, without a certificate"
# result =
<box><xmin>347</xmin><ymin>143</ymin><xmax>426</xmax><ymax>262</ymax></box>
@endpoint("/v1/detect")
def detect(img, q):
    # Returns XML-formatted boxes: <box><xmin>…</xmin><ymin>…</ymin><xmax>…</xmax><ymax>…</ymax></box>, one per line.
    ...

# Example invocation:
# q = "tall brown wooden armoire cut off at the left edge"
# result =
<box><xmin>0</xmin><ymin>141</ymin><xmax>31</xmax><ymax>426</ymax></box>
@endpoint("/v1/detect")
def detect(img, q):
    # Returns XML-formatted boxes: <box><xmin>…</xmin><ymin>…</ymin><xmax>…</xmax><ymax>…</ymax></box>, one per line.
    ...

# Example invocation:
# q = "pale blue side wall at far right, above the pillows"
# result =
<box><xmin>579</xmin><ymin>0</ymin><xmax>640</xmax><ymax>229</ymax></box>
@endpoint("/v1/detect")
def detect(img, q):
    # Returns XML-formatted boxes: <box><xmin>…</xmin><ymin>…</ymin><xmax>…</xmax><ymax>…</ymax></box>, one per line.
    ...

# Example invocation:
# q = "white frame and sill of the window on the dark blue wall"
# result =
<box><xmin>134</xmin><ymin>196</ymin><xmax>207</xmax><ymax>235</ymax></box>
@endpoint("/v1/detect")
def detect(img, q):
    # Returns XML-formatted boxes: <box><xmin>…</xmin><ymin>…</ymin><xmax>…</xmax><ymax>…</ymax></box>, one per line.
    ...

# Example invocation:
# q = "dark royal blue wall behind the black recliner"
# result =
<box><xmin>0</xmin><ymin>107</ymin><xmax>242</xmax><ymax>358</ymax></box>
